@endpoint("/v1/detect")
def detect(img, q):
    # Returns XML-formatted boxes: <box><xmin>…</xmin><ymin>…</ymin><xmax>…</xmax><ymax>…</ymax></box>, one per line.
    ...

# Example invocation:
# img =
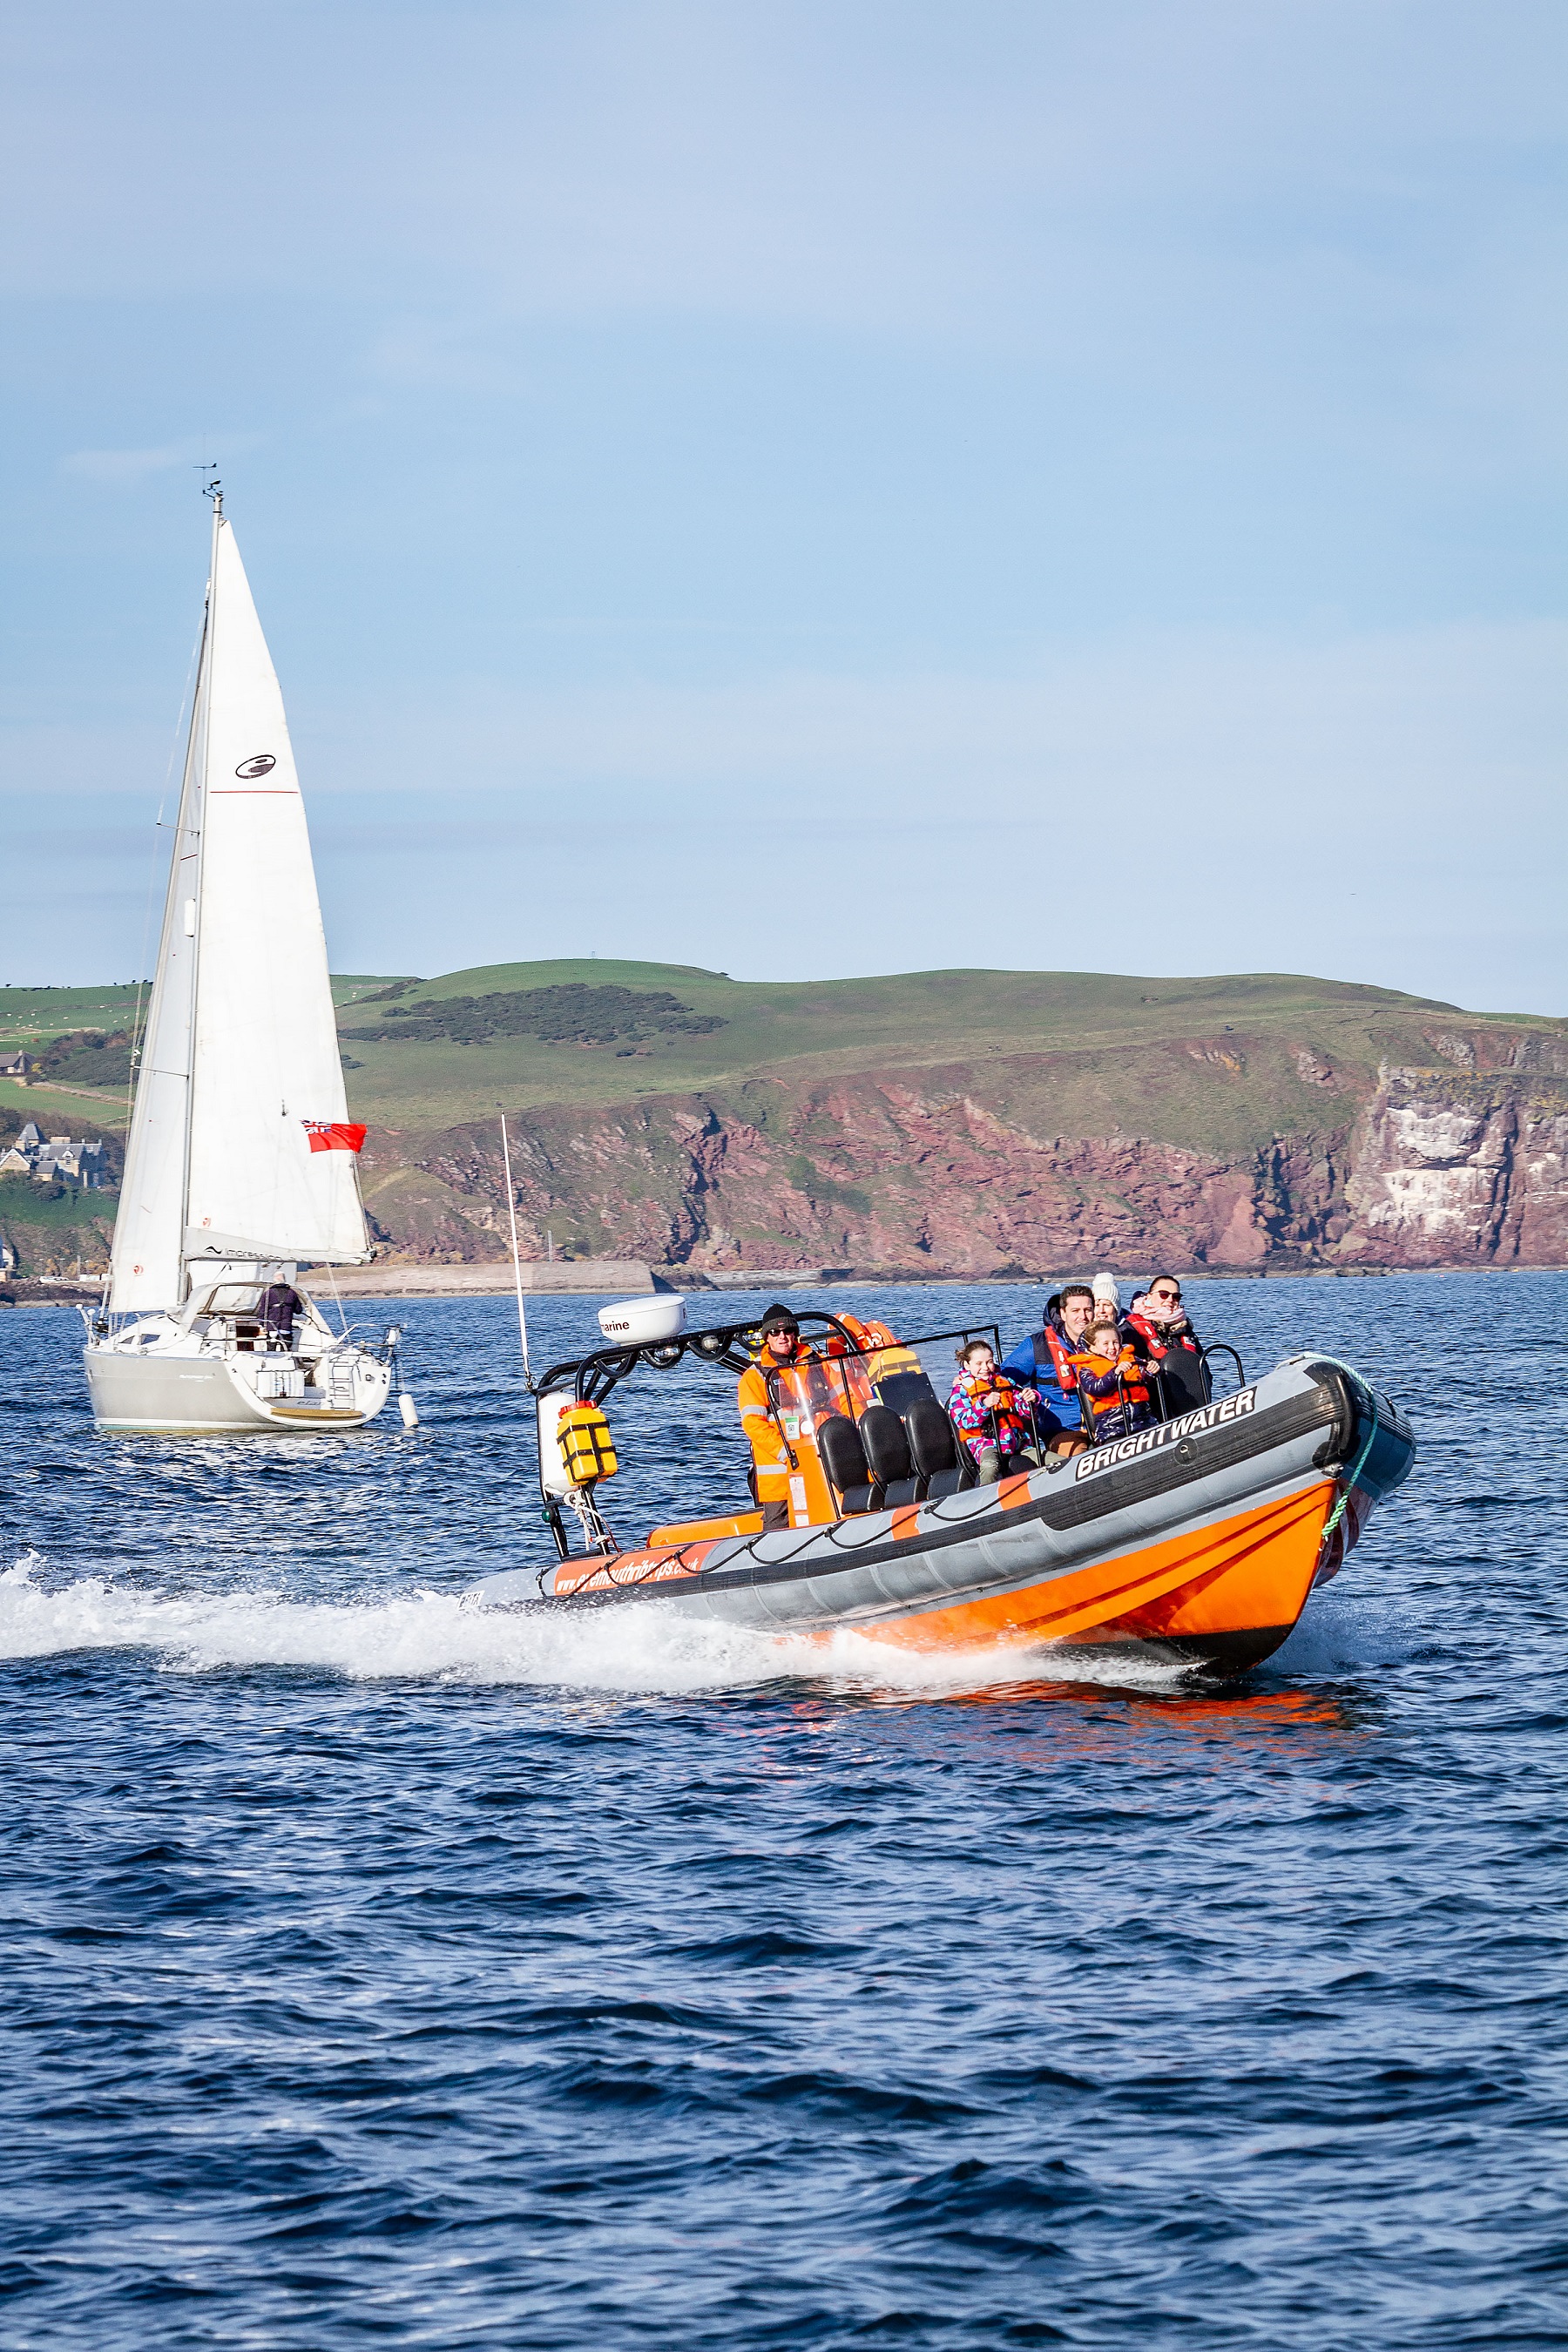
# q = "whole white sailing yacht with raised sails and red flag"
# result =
<box><xmin>84</xmin><ymin>483</ymin><xmax>409</xmax><ymax>1435</ymax></box>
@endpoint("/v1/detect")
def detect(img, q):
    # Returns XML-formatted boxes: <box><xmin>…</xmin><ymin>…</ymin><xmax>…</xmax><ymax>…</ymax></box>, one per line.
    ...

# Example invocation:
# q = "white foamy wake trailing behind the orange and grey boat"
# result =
<box><xmin>0</xmin><ymin>1555</ymin><xmax>1185</xmax><ymax>1696</ymax></box>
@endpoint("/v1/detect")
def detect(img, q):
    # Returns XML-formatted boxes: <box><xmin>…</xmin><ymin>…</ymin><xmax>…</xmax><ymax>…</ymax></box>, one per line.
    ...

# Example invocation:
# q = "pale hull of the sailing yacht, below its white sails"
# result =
<box><xmin>82</xmin><ymin>1348</ymin><xmax>390</xmax><ymax>1437</ymax></box>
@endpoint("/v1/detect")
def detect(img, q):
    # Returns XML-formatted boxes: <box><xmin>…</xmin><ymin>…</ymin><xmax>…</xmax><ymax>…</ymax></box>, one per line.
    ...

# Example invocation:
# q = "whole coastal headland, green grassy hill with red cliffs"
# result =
<box><xmin>0</xmin><ymin>957</ymin><xmax>1568</xmax><ymax>1270</ymax></box>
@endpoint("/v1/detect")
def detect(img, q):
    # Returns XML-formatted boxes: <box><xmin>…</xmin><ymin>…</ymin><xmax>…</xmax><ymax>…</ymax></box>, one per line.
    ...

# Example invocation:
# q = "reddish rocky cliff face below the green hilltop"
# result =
<box><xmin>352</xmin><ymin>1028</ymin><xmax>1568</xmax><ymax>1274</ymax></box>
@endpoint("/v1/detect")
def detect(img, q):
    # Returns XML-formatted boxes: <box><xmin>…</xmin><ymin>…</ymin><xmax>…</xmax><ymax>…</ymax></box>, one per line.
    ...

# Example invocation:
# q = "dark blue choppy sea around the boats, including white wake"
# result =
<box><xmin>0</xmin><ymin>1274</ymin><xmax>1568</xmax><ymax>2352</ymax></box>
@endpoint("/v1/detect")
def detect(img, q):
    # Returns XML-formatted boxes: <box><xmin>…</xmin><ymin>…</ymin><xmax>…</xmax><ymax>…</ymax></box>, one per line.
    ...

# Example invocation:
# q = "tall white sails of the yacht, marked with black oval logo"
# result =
<box><xmin>108</xmin><ymin>508</ymin><xmax>367</xmax><ymax>1313</ymax></box>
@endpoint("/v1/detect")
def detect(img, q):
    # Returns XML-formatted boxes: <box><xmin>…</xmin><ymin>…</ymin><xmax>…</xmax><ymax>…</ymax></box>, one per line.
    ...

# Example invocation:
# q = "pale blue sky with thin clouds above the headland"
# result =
<box><xmin>0</xmin><ymin>0</ymin><xmax>1568</xmax><ymax>1014</ymax></box>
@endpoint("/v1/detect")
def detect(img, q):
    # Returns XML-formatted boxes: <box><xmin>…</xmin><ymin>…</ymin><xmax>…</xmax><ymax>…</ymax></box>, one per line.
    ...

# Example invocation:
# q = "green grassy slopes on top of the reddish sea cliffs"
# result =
<box><xmin>0</xmin><ymin>960</ymin><xmax>1557</xmax><ymax>1148</ymax></box>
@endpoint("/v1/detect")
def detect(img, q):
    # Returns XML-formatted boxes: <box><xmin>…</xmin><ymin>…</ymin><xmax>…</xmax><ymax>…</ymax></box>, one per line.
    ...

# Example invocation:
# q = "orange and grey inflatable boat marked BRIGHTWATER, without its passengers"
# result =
<box><xmin>470</xmin><ymin>1301</ymin><xmax>1416</xmax><ymax>1677</ymax></box>
